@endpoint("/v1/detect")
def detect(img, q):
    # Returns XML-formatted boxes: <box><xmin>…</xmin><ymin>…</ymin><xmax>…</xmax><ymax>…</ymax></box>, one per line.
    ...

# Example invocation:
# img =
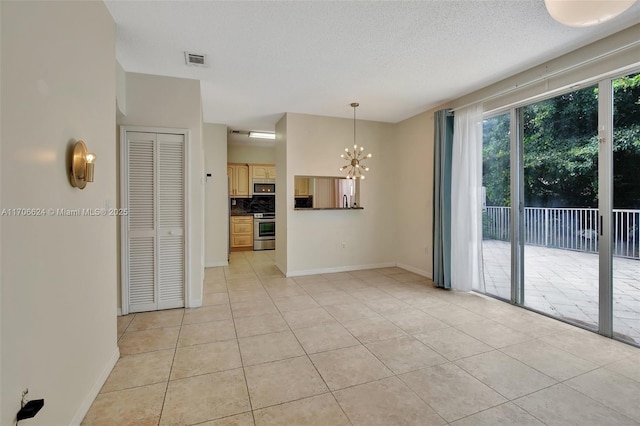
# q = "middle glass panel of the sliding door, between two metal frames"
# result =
<box><xmin>522</xmin><ymin>86</ymin><xmax>599</xmax><ymax>330</ymax></box>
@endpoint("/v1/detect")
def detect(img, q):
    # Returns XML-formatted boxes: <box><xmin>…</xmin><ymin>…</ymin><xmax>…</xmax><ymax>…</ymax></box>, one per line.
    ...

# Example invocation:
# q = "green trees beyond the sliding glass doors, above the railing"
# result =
<box><xmin>483</xmin><ymin>74</ymin><xmax>640</xmax><ymax>208</ymax></box>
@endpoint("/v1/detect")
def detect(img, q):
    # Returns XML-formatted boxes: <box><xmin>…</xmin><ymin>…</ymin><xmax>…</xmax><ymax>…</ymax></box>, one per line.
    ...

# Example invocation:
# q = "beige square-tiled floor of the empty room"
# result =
<box><xmin>83</xmin><ymin>252</ymin><xmax>640</xmax><ymax>426</ymax></box>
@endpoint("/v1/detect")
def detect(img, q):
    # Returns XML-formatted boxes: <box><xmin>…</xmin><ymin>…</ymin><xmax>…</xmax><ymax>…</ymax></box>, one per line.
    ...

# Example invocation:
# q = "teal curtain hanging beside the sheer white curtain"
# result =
<box><xmin>433</xmin><ymin>109</ymin><xmax>453</xmax><ymax>288</ymax></box>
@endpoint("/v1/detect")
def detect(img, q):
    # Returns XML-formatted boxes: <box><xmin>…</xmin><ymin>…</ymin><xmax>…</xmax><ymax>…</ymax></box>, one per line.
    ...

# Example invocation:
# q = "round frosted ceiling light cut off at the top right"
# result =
<box><xmin>544</xmin><ymin>0</ymin><xmax>636</xmax><ymax>27</ymax></box>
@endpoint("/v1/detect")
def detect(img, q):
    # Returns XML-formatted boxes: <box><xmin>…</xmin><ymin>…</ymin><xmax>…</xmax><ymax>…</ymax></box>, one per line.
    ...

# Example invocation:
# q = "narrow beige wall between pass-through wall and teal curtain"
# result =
<box><xmin>394</xmin><ymin>108</ymin><xmax>441</xmax><ymax>278</ymax></box>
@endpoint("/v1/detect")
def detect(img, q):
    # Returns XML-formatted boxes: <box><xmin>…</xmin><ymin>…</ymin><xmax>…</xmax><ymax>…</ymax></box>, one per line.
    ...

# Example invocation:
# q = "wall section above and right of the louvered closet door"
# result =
<box><xmin>118</xmin><ymin>73</ymin><xmax>205</xmax><ymax>307</ymax></box>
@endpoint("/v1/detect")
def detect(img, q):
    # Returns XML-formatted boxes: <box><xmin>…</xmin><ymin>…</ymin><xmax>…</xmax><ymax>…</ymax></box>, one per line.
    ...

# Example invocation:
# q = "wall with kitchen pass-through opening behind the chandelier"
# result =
<box><xmin>284</xmin><ymin>113</ymin><xmax>397</xmax><ymax>275</ymax></box>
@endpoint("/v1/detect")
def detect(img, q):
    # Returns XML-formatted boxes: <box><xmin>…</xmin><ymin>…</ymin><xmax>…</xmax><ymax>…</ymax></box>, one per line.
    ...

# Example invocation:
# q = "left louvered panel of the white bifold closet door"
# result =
<box><xmin>127</xmin><ymin>132</ymin><xmax>158</xmax><ymax>312</ymax></box>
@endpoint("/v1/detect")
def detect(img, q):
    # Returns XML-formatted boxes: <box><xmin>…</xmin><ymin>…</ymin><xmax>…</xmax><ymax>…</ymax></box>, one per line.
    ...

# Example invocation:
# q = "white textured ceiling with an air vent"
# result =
<box><xmin>105</xmin><ymin>0</ymin><xmax>640</xmax><ymax>131</ymax></box>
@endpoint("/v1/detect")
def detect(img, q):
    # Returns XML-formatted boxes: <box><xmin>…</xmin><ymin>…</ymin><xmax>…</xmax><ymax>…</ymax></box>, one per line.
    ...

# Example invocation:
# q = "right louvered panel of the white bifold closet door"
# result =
<box><xmin>157</xmin><ymin>134</ymin><xmax>185</xmax><ymax>309</ymax></box>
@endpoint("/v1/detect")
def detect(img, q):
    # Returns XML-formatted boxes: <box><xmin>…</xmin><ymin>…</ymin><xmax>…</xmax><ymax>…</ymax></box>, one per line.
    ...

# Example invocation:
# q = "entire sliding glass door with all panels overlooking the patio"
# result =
<box><xmin>482</xmin><ymin>74</ymin><xmax>640</xmax><ymax>345</ymax></box>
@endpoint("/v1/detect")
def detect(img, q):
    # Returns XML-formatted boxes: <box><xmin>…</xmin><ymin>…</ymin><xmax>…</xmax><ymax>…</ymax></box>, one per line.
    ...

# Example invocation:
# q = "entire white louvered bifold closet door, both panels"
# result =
<box><xmin>122</xmin><ymin>131</ymin><xmax>186</xmax><ymax>313</ymax></box>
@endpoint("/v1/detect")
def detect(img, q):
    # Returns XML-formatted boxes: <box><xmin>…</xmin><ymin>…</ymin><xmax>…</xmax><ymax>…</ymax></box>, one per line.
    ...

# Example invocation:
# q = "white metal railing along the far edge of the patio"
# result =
<box><xmin>482</xmin><ymin>206</ymin><xmax>640</xmax><ymax>259</ymax></box>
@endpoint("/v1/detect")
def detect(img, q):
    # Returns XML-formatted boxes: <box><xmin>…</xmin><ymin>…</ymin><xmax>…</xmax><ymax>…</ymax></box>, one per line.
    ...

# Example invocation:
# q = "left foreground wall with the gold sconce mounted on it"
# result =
<box><xmin>0</xmin><ymin>2</ymin><xmax>119</xmax><ymax>425</ymax></box>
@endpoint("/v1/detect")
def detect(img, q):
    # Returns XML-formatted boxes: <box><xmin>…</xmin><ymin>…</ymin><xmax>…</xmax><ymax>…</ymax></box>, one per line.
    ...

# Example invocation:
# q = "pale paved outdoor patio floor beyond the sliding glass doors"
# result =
<box><xmin>483</xmin><ymin>240</ymin><xmax>640</xmax><ymax>345</ymax></box>
